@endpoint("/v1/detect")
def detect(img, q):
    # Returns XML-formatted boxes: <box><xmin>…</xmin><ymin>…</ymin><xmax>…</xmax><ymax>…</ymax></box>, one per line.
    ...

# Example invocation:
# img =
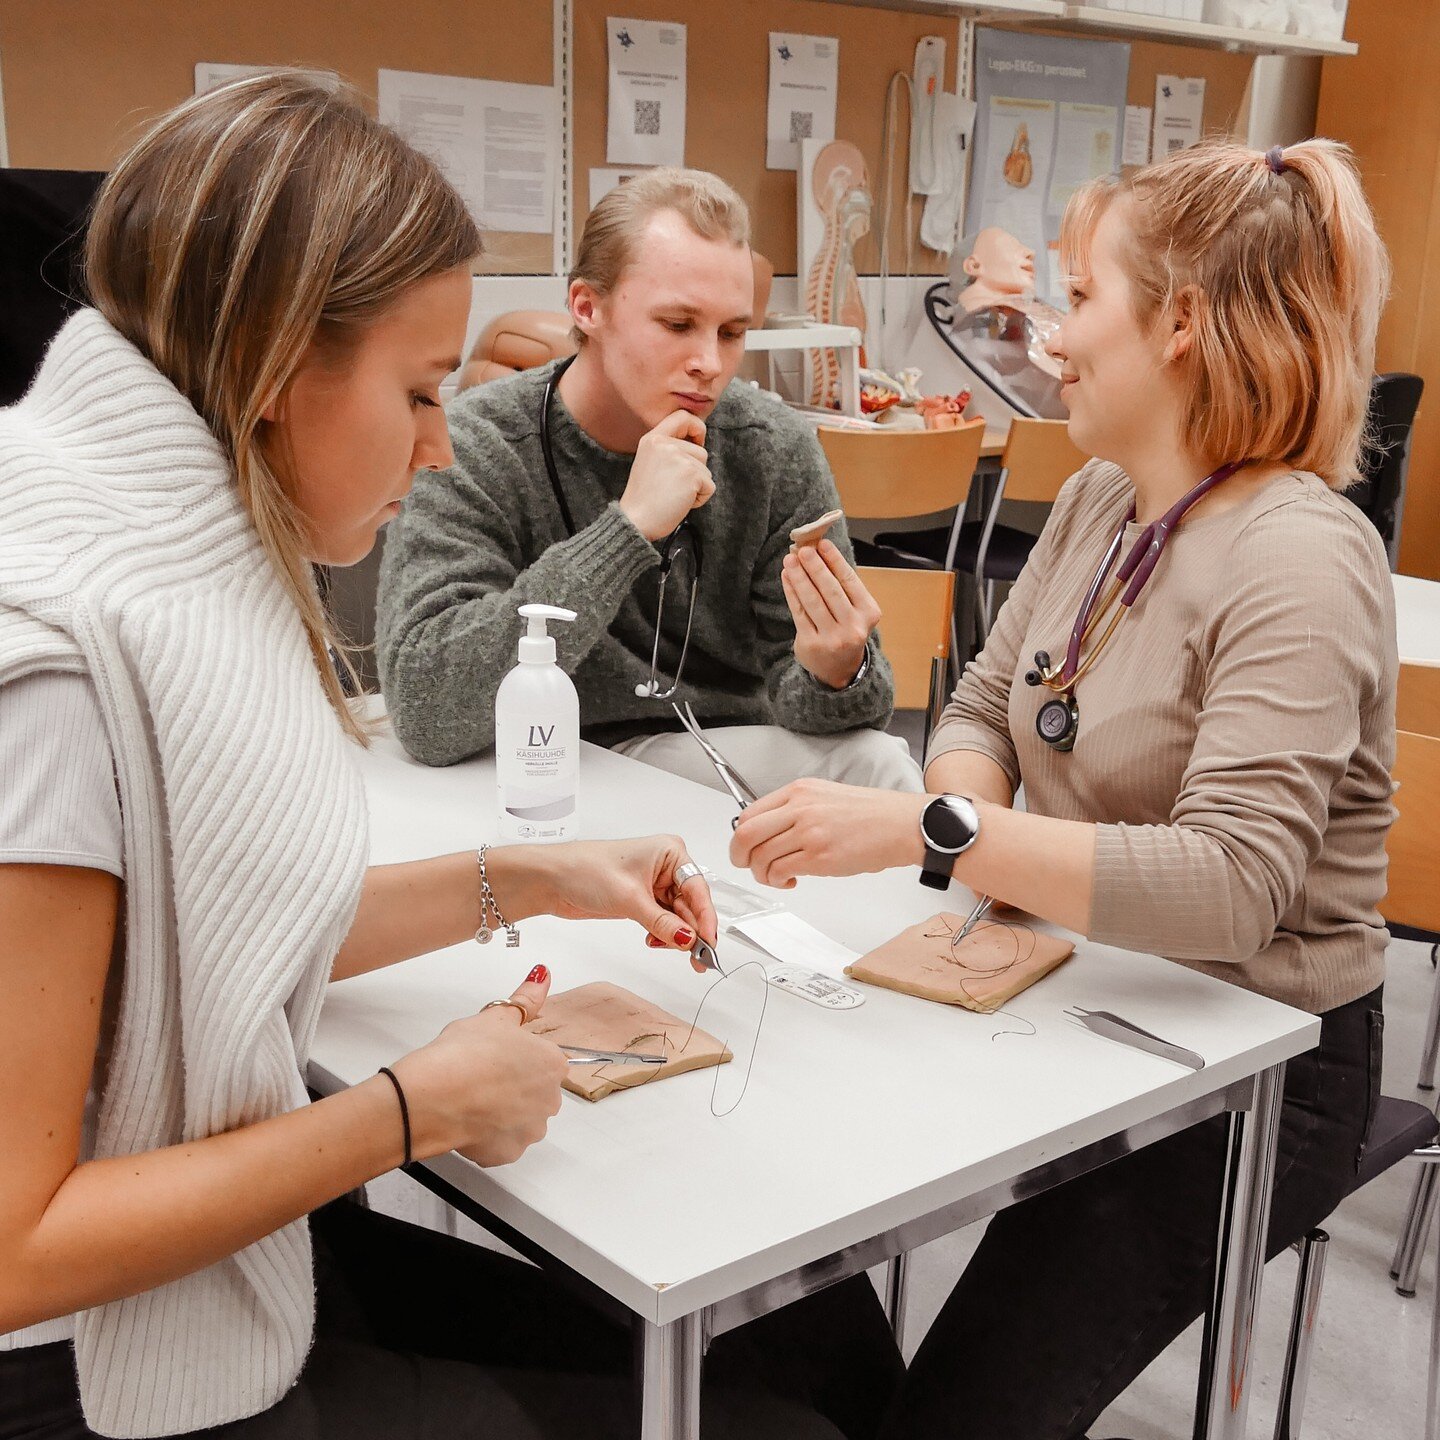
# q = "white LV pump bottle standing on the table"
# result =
<box><xmin>495</xmin><ymin>605</ymin><xmax>580</xmax><ymax>844</ymax></box>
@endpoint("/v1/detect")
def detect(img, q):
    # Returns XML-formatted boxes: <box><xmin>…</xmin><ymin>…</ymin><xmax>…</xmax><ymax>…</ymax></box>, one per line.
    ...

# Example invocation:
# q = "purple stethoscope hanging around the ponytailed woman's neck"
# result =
<box><xmin>1025</xmin><ymin>461</ymin><xmax>1246</xmax><ymax>750</ymax></box>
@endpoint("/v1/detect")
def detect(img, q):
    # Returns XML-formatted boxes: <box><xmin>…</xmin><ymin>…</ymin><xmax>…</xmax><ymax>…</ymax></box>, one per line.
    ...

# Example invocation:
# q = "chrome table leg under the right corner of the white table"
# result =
<box><xmin>1195</xmin><ymin>1066</ymin><xmax>1284</xmax><ymax>1440</ymax></box>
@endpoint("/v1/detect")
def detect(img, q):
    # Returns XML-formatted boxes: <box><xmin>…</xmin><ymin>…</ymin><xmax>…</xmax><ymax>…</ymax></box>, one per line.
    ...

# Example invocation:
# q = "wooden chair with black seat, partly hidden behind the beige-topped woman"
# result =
<box><xmin>876</xmin><ymin>418</ymin><xmax>1090</xmax><ymax>639</ymax></box>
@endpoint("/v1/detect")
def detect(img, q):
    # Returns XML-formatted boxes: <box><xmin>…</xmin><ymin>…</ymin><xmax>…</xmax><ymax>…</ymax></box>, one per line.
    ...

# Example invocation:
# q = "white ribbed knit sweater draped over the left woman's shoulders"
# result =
<box><xmin>0</xmin><ymin>311</ymin><xmax>366</xmax><ymax>1436</ymax></box>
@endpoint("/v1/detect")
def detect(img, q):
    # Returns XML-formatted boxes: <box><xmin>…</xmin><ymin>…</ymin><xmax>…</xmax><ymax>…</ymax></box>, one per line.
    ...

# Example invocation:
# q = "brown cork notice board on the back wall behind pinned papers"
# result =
<box><xmin>0</xmin><ymin>0</ymin><xmax>1250</xmax><ymax>275</ymax></box>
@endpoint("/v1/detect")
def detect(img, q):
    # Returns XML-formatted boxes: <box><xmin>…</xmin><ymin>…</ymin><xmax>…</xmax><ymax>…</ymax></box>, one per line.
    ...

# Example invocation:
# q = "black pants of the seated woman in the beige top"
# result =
<box><xmin>883</xmin><ymin>989</ymin><xmax>1382</xmax><ymax>1440</ymax></box>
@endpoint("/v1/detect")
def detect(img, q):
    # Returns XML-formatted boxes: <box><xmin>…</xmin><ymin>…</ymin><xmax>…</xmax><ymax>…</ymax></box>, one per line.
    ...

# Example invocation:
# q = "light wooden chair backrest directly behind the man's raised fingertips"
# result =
<box><xmin>819</xmin><ymin>420</ymin><xmax>985</xmax><ymax>520</ymax></box>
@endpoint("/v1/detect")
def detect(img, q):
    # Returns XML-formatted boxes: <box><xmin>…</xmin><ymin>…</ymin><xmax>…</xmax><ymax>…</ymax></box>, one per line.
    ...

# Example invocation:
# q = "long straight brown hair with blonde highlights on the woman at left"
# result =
<box><xmin>85</xmin><ymin>71</ymin><xmax>481</xmax><ymax>743</ymax></box>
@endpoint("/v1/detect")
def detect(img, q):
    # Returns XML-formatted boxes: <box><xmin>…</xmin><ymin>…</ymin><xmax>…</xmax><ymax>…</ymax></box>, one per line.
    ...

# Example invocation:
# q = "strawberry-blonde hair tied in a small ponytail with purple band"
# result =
<box><xmin>1060</xmin><ymin>140</ymin><xmax>1390</xmax><ymax>490</ymax></box>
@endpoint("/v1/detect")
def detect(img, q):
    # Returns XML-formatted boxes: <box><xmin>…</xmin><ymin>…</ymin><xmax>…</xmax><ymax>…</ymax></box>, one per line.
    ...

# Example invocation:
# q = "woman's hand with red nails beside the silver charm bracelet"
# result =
<box><xmin>546</xmin><ymin>835</ymin><xmax>716</xmax><ymax>950</ymax></box>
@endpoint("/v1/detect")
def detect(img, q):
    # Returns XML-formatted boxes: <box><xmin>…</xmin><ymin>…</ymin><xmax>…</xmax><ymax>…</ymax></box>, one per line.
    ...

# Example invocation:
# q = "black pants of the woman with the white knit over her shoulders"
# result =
<box><xmin>0</xmin><ymin>1201</ymin><xmax>903</xmax><ymax>1440</ymax></box>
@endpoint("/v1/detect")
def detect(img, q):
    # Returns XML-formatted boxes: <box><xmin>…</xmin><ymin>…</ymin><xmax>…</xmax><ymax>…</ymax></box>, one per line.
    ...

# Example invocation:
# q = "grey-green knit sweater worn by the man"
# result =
<box><xmin>376</xmin><ymin>367</ymin><xmax>894</xmax><ymax>765</ymax></box>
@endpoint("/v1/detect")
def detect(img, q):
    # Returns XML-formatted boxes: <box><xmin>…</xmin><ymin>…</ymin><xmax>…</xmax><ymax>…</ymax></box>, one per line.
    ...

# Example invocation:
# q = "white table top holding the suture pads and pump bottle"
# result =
<box><xmin>312</xmin><ymin>737</ymin><xmax>1319</xmax><ymax>1325</ymax></box>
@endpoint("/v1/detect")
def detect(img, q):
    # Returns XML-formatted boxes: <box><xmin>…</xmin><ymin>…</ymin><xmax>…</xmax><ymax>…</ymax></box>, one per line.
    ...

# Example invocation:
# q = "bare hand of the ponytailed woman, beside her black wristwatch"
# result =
<box><xmin>730</xmin><ymin>779</ymin><xmax>933</xmax><ymax>890</ymax></box>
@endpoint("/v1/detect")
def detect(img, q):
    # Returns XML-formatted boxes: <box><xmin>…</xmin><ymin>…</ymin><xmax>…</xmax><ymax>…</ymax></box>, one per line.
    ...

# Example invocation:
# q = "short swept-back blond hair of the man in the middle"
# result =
<box><xmin>570</xmin><ymin>166</ymin><xmax>750</xmax><ymax>344</ymax></box>
